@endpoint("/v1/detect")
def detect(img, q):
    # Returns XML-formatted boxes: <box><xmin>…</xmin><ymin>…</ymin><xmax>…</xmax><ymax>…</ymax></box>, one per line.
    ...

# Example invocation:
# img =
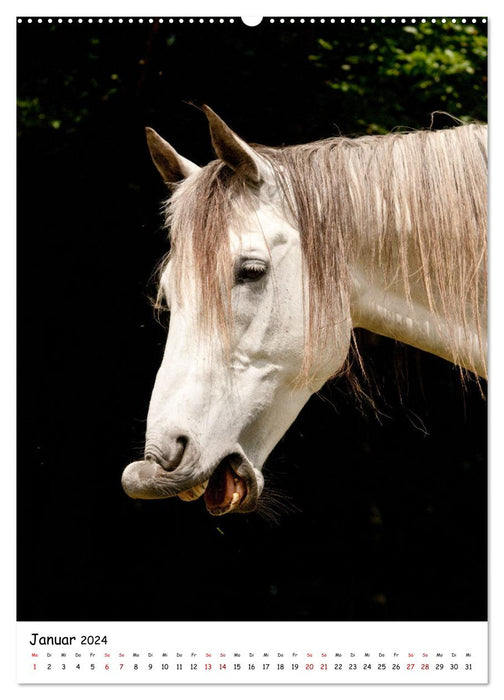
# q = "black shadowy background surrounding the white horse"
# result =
<box><xmin>18</xmin><ymin>19</ymin><xmax>487</xmax><ymax>620</ymax></box>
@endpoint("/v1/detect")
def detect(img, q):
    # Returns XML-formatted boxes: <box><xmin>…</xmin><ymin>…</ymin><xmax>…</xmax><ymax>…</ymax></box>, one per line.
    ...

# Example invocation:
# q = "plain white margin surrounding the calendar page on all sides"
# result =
<box><xmin>4</xmin><ymin>0</ymin><xmax>504</xmax><ymax>700</ymax></box>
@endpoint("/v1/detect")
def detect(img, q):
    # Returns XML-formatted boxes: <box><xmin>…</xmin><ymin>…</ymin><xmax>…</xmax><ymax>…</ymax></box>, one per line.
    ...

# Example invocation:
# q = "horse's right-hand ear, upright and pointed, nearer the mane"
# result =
<box><xmin>203</xmin><ymin>105</ymin><xmax>262</xmax><ymax>184</ymax></box>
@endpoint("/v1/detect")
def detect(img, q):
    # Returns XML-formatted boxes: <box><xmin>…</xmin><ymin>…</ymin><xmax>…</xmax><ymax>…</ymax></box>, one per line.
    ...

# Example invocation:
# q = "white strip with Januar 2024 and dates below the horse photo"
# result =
<box><xmin>18</xmin><ymin>622</ymin><xmax>488</xmax><ymax>684</ymax></box>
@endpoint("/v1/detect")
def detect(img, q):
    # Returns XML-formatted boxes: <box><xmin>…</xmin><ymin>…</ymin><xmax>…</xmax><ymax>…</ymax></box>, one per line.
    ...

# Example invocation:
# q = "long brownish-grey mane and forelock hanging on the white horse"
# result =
<box><xmin>158</xmin><ymin>124</ymin><xmax>487</xmax><ymax>378</ymax></box>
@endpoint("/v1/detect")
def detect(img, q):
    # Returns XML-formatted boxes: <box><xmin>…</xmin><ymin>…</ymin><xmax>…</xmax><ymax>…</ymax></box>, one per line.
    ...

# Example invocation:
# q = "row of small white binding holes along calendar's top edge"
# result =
<box><xmin>17</xmin><ymin>17</ymin><xmax>486</xmax><ymax>24</ymax></box>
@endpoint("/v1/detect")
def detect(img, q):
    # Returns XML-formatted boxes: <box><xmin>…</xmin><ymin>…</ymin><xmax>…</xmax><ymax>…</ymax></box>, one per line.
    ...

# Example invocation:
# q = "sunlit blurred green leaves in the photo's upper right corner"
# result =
<box><xmin>308</xmin><ymin>21</ymin><xmax>487</xmax><ymax>133</ymax></box>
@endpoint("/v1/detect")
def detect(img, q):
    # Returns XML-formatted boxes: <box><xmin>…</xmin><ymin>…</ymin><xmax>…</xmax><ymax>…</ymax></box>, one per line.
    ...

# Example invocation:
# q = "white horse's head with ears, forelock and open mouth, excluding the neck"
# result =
<box><xmin>122</xmin><ymin>108</ymin><xmax>351</xmax><ymax>514</ymax></box>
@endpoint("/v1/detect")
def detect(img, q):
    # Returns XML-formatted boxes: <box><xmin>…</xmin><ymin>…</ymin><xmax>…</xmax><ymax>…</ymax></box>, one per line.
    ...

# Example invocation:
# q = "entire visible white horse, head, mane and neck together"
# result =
<box><xmin>122</xmin><ymin>107</ymin><xmax>487</xmax><ymax>515</ymax></box>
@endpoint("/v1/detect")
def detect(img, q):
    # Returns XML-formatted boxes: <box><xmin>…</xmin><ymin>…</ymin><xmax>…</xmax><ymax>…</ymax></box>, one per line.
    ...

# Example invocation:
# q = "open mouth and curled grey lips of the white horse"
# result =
<box><xmin>122</xmin><ymin>453</ymin><xmax>264</xmax><ymax>515</ymax></box>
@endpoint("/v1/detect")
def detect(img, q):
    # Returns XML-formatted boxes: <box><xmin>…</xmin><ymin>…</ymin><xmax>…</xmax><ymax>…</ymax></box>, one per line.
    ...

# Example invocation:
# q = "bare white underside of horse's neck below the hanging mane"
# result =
<box><xmin>351</xmin><ymin>259</ymin><xmax>486</xmax><ymax>377</ymax></box>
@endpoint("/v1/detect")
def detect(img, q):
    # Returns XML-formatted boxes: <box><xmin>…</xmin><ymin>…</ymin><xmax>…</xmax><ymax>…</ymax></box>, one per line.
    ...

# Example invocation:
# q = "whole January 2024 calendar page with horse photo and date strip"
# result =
<box><xmin>14</xmin><ymin>6</ymin><xmax>489</xmax><ymax>686</ymax></box>
